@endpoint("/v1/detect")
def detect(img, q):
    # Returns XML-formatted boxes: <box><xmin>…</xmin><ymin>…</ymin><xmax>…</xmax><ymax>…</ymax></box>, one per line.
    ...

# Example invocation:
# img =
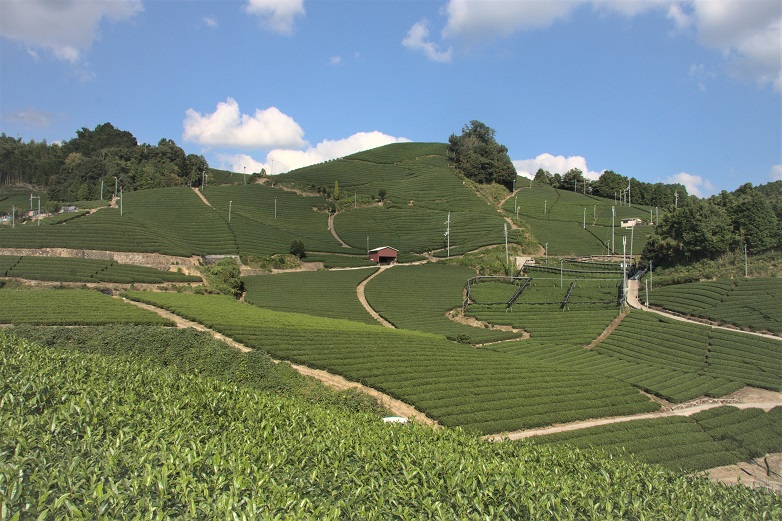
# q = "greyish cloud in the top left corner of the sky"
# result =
<box><xmin>0</xmin><ymin>0</ymin><xmax>143</xmax><ymax>64</ymax></box>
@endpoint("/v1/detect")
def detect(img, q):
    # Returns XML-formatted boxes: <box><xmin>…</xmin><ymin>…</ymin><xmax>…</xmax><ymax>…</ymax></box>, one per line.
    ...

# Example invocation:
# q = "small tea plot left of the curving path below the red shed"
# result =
<box><xmin>243</xmin><ymin>268</ymin><xmax>377</xmax><ymax>324</ymax></box>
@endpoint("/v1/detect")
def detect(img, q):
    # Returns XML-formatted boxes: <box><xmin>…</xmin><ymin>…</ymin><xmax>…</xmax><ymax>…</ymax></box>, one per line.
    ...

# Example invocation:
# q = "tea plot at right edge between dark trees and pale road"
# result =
<box><xmin>649</xmin><ymin>278</ymin><xmax>782</xmax><ymax>333</ymax></box>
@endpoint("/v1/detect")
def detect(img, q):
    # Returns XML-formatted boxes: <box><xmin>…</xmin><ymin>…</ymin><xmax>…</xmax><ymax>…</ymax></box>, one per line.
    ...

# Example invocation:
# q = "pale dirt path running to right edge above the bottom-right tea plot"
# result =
<box><xmin>484</xmin><ymin>387</ymin><xmax>782</xmax><ymax>441</ymax></box>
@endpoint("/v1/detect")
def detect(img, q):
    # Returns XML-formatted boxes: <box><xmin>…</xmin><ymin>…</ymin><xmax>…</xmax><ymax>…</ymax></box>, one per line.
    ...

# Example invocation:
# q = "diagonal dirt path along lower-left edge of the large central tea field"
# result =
<box><xmin>122</xmin><ymin>298</ymin><xmax>437</xmax><ymax>425</ymax></box>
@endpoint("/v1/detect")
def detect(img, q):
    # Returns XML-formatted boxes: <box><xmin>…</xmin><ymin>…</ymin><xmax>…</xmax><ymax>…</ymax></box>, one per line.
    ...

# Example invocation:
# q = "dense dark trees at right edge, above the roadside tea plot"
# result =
<box><xmin>644</xmin><ymin>181</ymin><xmax>782</xmax><ymax>266</ymax></box>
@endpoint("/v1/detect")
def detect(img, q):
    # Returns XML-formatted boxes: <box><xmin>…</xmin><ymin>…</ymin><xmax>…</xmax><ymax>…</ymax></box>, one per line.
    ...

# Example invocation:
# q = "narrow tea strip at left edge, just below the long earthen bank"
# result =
<box><xmin>0</xmin><ymin>255</ymin><xmax>201</xmax><ymax>284</ymax></box>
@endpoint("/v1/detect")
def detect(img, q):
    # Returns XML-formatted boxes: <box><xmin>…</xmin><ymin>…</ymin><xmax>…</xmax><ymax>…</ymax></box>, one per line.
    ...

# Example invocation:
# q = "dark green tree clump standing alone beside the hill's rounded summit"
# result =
<box><xmin>446</xmin><ymin>120</ymin><xmax>516</xmax><ymax>190</ymax></box>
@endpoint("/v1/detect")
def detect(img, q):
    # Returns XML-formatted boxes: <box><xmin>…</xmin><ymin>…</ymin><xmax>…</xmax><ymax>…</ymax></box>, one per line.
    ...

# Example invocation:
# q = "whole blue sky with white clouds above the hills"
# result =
<box><xmin>0</xmin><ymin>0</ymin><xmax>782</xmax><ymax>196</ymax></box>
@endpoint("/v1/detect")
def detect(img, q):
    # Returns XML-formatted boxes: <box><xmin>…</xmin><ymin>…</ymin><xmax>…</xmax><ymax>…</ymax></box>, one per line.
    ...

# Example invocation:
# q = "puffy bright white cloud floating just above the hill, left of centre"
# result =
<box><xmin>182</xmin><ymin>98</ymin><xmax>306</xmax><ymax>149</ymax></box>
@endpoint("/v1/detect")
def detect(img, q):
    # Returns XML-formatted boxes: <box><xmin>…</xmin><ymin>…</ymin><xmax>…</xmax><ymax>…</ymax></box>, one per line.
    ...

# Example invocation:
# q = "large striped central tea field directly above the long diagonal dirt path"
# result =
<box><xmin>128</xmin><ymin>292</ymin><xmax>659</xmax><ymax>433</ymax></box>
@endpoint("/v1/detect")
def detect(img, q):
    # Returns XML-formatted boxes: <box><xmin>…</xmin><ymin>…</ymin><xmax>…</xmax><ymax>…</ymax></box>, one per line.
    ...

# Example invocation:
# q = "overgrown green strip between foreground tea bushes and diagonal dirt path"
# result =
<box><xmin>13</xmin><ymin>325</ymin><xmax>385</xmax><ymax>414</ymax></box>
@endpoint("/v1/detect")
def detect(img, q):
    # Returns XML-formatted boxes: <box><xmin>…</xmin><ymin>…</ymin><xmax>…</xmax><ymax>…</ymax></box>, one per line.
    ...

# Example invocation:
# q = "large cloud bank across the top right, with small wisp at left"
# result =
<box><xmin>432</xmin><ymin>0</ymin><xmax>782</xmax><ymax>91</ymax></box>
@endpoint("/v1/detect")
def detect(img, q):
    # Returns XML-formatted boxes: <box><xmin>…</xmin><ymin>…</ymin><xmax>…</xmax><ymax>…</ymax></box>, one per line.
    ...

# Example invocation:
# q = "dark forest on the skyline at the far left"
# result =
<box><xmin>0</xmin><ymin>123</ymin><xmax>209</xmax><ymax>201</ymax></box>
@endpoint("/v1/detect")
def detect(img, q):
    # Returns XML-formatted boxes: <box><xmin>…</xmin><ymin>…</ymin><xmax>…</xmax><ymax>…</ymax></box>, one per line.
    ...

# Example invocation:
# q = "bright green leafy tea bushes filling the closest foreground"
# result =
<box><xmin>0</xmin><ymin>334</ymin><xmax>782</xmax><ymax>519</ymax></box>
